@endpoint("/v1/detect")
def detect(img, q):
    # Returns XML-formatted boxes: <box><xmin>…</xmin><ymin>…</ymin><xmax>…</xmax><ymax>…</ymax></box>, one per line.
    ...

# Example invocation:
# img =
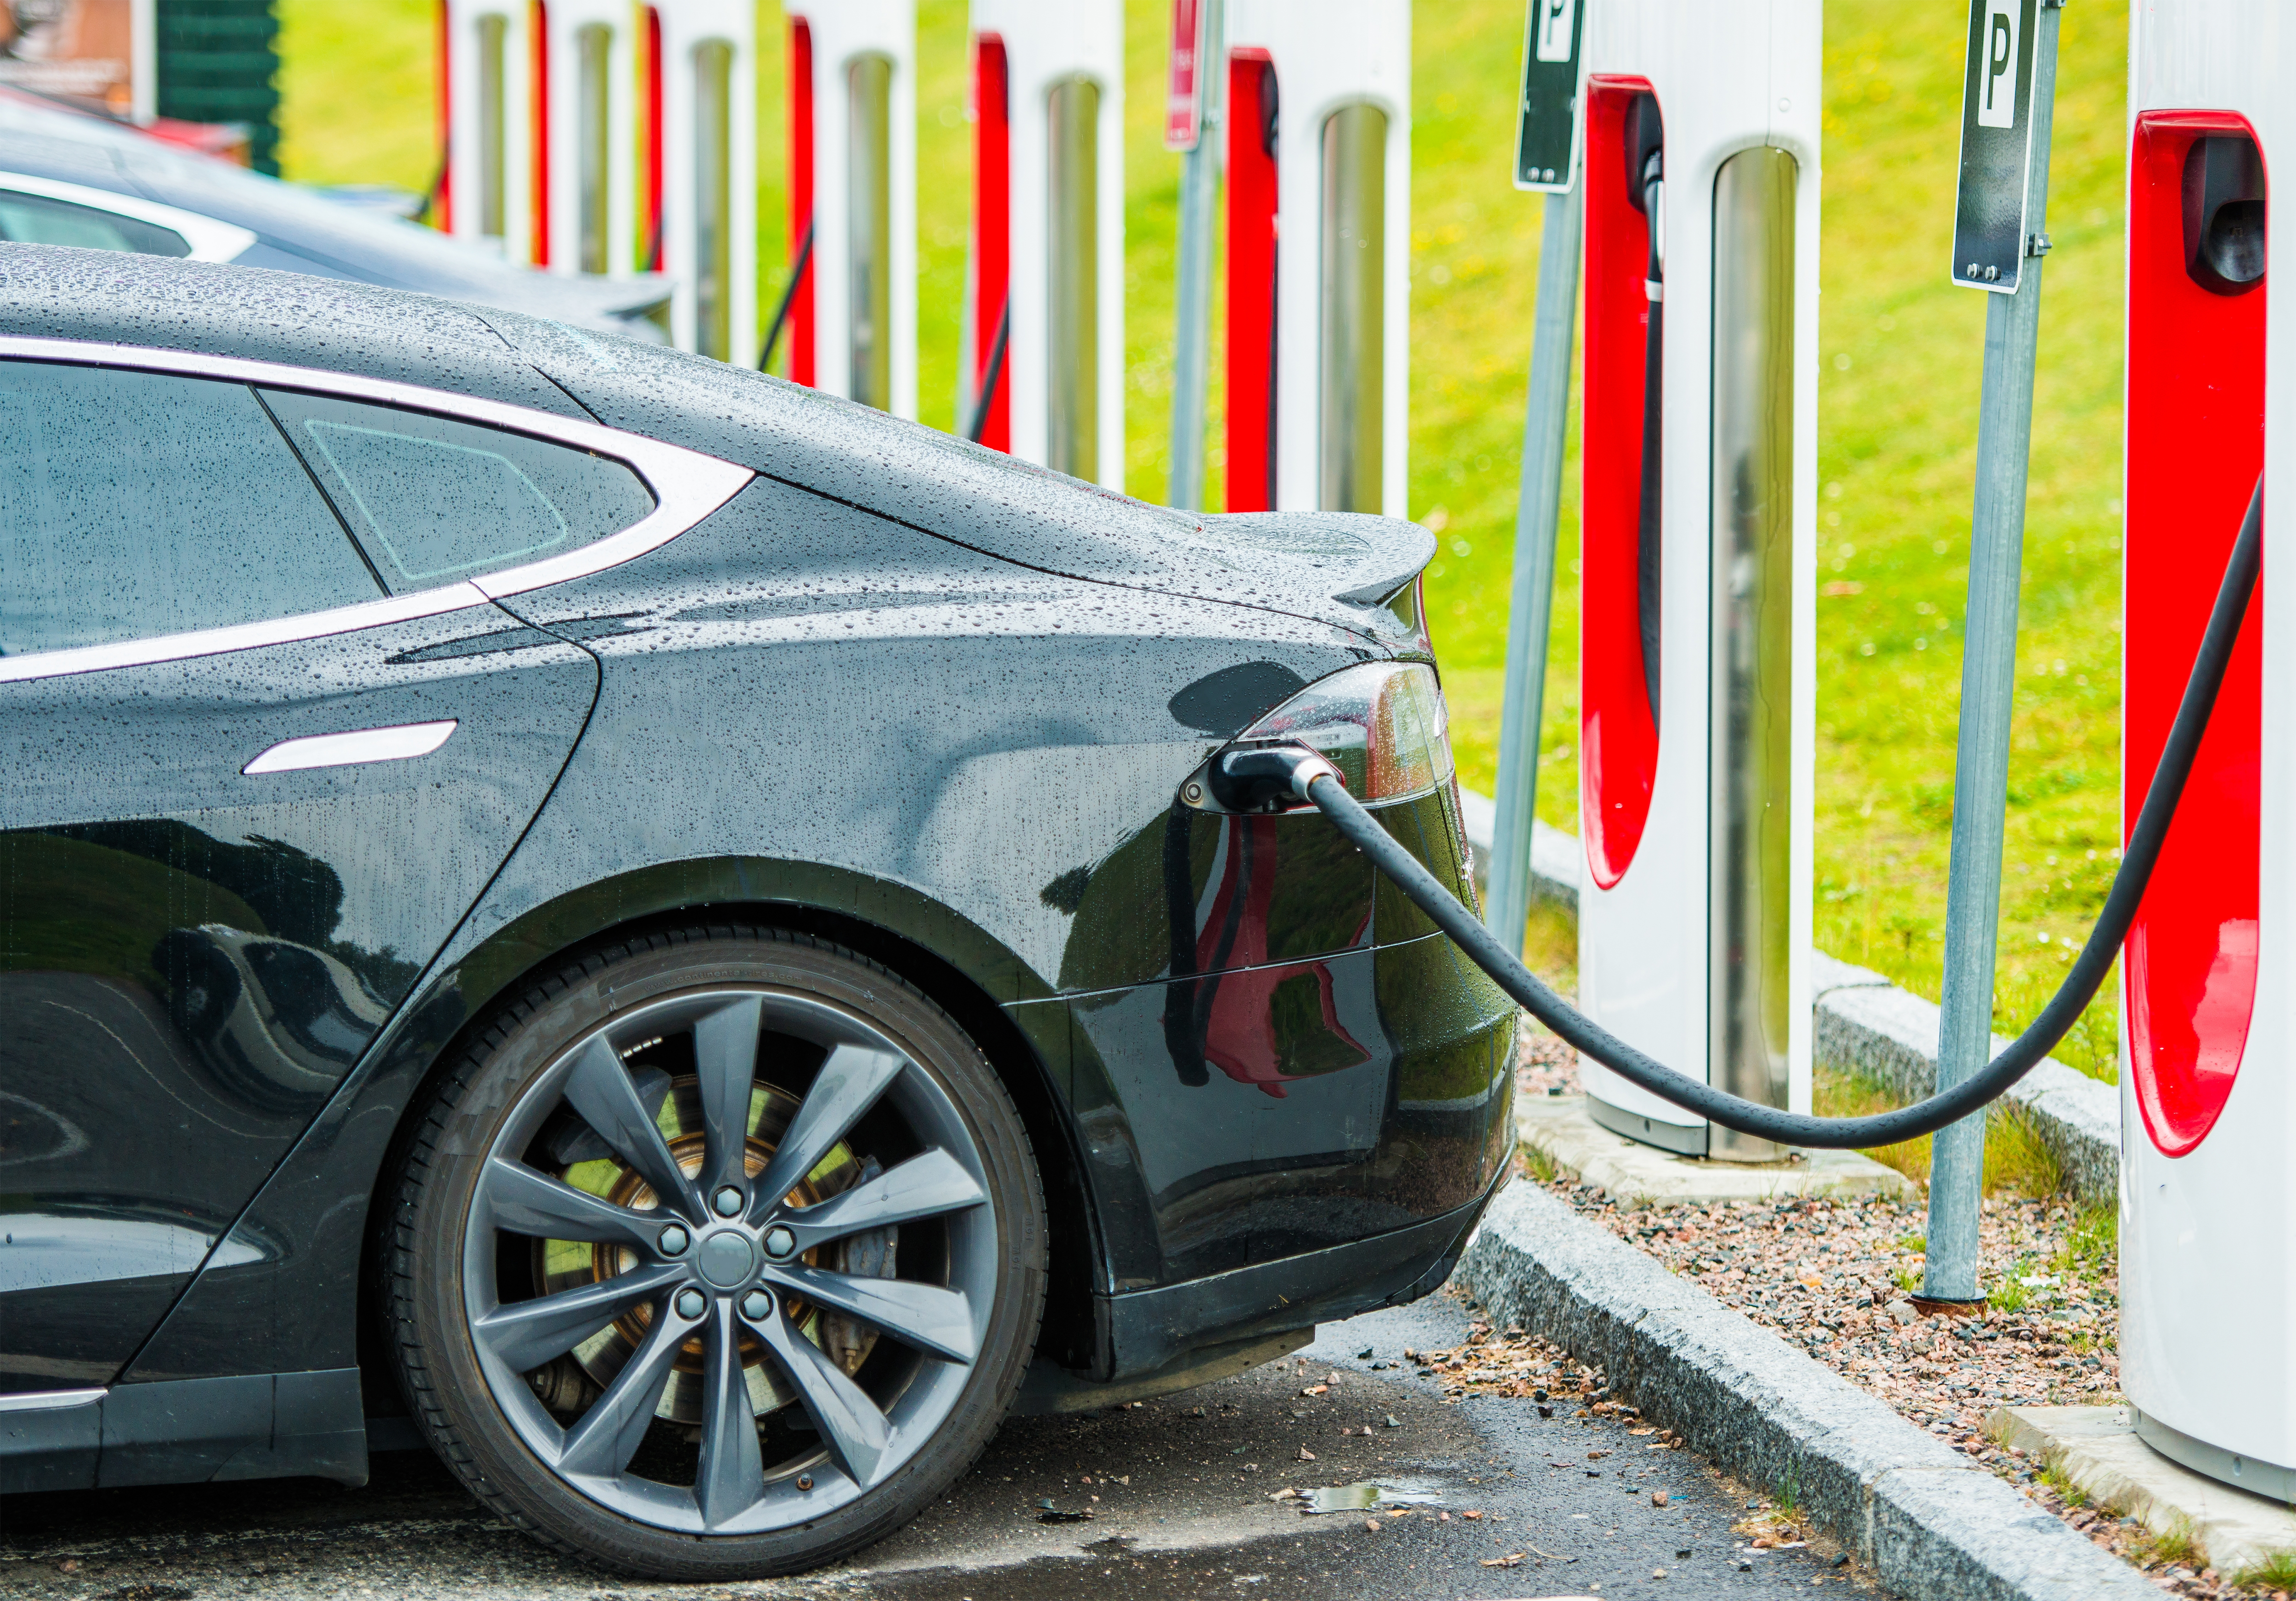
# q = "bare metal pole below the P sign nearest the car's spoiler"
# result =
<box><xmin>1483</xmin><ymin>186</ymin><xmax>1580</xmax><ymax>958</ymax></box>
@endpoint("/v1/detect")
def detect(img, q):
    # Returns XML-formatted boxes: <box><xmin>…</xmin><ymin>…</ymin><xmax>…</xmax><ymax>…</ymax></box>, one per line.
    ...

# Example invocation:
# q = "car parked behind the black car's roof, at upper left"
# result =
<box><xmin>0</xmin><ymin>87</ymin><xmax>670</xmax><ymax>344</ymax></box>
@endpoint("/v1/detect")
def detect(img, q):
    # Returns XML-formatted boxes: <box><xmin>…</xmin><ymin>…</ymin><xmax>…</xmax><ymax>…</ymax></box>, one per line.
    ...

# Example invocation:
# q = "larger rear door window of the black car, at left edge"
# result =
<box><xmin>0</xmin><ymin>361</ymin><xmax>377</xmax><ymax>654</ymax></box>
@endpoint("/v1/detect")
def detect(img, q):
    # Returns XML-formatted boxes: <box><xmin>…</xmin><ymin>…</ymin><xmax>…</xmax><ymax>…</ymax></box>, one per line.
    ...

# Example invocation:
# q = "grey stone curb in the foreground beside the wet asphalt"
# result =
<box><xmin>1451</xmin><ymin>1183</ymin><xmax>2161</xmax><ymax>1601</ymax></box>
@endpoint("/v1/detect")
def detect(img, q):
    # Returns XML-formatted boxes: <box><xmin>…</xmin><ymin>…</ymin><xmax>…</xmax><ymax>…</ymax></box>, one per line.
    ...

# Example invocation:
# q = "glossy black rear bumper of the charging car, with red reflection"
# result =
<box><xmin>1006</xmin><ymin>919</ymin><xmax>1520</xmax><ymax>1295</ymax></box>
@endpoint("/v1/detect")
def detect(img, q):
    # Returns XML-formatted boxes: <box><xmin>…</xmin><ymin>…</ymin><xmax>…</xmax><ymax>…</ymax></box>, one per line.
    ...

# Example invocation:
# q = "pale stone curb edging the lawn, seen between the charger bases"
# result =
<box><xmin>1458</xmin><ymin>790</ymin><xmax>2122</xmax><ymax>1204</ymax></box>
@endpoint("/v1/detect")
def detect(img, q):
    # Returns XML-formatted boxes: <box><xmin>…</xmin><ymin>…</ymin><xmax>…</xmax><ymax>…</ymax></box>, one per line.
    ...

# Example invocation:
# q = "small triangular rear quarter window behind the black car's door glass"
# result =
<box><xmin>264</xmin><ymin>390</ymin><xmax>654</xmax><ymax>590</ymax></box>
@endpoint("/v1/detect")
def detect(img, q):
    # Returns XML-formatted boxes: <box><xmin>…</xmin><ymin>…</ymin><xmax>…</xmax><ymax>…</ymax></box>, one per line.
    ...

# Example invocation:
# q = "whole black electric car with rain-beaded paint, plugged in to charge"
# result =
<box><xmin>0</xmin><ymin>246</ymin><xmax>1515</xmax><ymax>1578</ymax></box>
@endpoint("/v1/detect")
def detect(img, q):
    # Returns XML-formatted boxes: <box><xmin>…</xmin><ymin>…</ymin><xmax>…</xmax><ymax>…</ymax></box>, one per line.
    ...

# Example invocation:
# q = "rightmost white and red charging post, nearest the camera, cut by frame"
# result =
<box><xmin>2119</xmin><ymin>0</ymin><xmax>2296</xmax><ymax>1502</ymax></box>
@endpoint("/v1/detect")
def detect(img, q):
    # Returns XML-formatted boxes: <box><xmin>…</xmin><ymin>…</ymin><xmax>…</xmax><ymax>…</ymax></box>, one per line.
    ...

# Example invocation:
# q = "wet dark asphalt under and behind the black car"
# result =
<box><xmin>0</xmin><ymin>1293</ymin><xmax>1871</xmax><ymax>1601</ymax></box>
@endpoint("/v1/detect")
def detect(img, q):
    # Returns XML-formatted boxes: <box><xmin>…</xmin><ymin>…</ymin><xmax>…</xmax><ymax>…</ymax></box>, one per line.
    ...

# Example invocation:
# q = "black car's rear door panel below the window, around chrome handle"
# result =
<box><xmin>0</xmin><ymin>606</ymin><xmax>597</xmax><ymax>1392</ymax></box>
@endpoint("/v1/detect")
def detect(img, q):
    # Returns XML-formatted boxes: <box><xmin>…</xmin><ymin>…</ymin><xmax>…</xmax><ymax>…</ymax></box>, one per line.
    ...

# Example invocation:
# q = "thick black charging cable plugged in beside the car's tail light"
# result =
<box><xmin>1217</xmin><ymin>475</ymin><xmax>2264</xmax><ymax>1151</ymax></box>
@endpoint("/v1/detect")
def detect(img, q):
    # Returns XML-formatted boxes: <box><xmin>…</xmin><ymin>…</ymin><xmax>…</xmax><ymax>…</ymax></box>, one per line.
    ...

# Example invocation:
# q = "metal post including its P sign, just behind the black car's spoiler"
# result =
<box><xmin>1483</xmin><ymin>0</ymin><xmax>1584</xmax><ymax>956</ymax></box>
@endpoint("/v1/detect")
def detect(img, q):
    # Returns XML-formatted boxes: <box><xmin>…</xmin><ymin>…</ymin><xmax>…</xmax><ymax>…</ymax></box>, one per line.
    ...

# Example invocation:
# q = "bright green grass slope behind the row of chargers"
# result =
<box><xmin>278</xmin><ymin>0</ymin><xmax>2128</xmax><ymax>1077</ymax></box>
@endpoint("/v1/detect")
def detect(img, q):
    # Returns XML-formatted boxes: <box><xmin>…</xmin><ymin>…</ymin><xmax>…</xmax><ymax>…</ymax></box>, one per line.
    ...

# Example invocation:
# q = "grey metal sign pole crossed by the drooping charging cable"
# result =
<box><xmin>1922</xmin><ymin>0</ymin><xmax>2062</xmax><ymax>1300</ymax></box>
